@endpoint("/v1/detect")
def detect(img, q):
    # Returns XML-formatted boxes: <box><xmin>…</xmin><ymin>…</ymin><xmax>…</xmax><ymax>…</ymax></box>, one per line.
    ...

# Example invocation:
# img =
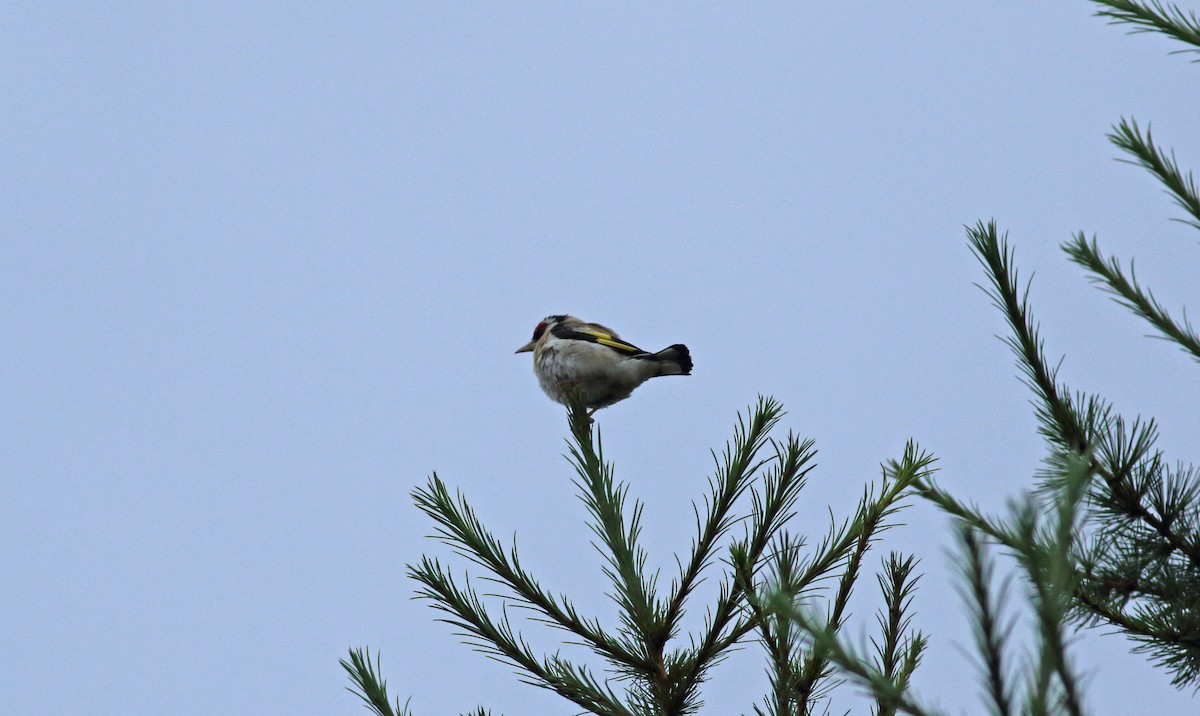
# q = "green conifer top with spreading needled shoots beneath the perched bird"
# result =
<box><xmin>342</xmin><ymin>398</ymin><xmax>932</xmax><ymax>716</ymax></box>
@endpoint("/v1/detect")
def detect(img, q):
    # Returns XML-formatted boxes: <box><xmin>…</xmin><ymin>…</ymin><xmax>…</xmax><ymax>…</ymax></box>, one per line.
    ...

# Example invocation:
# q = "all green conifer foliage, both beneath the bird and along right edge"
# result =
<box><xmin>342</xmin><ymin>0</ymin><xmax>1200</xmax><ymax>716</ymax></box>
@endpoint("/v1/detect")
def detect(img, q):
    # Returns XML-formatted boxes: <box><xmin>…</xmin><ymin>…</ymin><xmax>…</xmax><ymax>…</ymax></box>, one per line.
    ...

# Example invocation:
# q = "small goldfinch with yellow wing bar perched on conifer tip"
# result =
<box><xmin>517</xmin><ymin>315</ymin><xmax>691</xmax><ymax>415</ymax></box>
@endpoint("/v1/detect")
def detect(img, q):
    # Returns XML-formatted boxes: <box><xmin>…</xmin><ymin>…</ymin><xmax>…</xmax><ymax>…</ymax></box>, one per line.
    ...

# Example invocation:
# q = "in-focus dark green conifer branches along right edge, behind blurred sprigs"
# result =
<box><xmin>923</xmin><ymin>0</ymin><xmax>1200</xmax><ymax>687</ymax></box>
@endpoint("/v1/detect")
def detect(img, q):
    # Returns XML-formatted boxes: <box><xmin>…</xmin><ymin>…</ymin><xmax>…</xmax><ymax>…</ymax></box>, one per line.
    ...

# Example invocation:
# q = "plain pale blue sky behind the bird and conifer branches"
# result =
<box><xmin>0</xmin><ymin>1</ymin><xmax>1200</xmax><ymax>716</ymax></box>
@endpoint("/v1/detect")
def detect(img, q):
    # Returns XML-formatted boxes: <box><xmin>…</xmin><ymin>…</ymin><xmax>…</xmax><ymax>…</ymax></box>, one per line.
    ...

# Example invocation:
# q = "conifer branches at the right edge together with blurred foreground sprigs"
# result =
<box><xmin>755</xmin><ymin>0</ymin><xmax>1200</xmax><ymax>715</ymax></box>
